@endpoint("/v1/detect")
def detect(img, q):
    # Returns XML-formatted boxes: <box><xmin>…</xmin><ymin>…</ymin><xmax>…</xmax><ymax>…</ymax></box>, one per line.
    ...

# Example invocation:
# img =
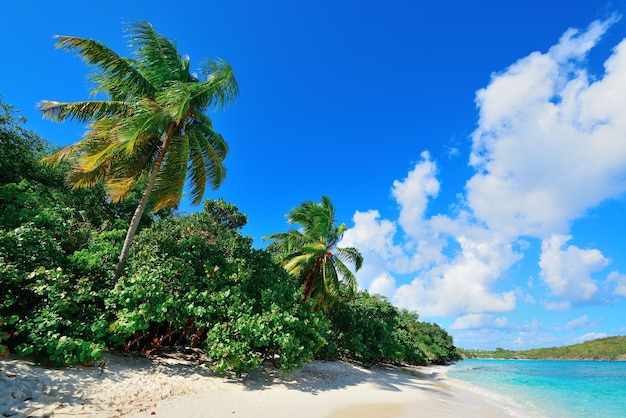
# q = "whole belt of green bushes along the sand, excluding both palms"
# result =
<box><xmin>0</xmin><ymin>96</ymin><xmax>454</xmax><ymax>374</ymax></box>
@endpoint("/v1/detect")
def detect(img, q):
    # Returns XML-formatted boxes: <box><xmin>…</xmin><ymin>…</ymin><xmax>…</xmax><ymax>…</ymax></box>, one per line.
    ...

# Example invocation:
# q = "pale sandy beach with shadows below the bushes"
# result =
<box><xmin>0</xmin><ymin>354</ymin><xmax>510</xmax><ymax>418</ymax></box>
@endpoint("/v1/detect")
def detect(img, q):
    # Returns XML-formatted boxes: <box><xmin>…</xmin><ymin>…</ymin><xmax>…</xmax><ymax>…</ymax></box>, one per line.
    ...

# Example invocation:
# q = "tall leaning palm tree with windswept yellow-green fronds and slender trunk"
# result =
<box><xmin>39</xmin><ymin>21</ymin><xmax>238</xmax><ymax>280</ymax></box>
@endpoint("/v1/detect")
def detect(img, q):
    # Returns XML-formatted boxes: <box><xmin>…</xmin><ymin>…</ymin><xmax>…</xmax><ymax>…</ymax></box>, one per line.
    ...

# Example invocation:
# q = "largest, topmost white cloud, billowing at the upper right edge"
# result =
<box><xmin>467</xmin><ymin>19</ymin><xmax>626</xmax><ymax>238</ymax></box>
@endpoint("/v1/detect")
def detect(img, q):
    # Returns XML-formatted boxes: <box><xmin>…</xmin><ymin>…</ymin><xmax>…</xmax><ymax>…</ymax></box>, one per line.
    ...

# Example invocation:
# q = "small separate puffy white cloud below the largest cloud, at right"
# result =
<box><xmin>539</xmin><ymin>235</ymin><xmax>609</xmax><ymax>303</ymax></box>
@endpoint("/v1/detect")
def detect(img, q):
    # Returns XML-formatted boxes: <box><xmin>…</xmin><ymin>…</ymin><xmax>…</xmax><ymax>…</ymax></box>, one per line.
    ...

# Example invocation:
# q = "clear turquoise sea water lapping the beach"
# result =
<box><xmin>446</xmin><ymin>360</ymin><xmax>626</xmax><ymax>418</ymax></box>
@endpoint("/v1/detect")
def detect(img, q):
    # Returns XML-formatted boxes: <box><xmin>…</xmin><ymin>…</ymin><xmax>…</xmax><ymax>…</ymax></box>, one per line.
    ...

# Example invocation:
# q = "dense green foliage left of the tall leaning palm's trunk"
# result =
<box><xmin>0</xmin><ymin>100</ymin><xmax>150</xmax><ymax>364</ymax></box>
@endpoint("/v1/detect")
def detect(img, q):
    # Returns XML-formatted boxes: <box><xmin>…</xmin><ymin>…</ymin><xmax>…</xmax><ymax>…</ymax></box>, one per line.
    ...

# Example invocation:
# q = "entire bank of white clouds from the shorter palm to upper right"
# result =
<box><xmin>341</xmin><ymin>18</ymin><xmax>626</xmax><ymax>324</ymax></box>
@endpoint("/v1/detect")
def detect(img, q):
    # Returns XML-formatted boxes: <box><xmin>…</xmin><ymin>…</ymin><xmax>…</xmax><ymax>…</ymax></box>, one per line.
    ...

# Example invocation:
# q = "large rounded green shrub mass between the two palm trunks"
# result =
<box><xmin>106</xmin><ymin>200</ymin><xmax>328</xmax><ymax>374</ymax></box>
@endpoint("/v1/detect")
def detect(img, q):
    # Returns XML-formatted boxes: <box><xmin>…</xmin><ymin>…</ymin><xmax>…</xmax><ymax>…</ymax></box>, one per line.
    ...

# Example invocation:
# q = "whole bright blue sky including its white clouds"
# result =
<box><xmin>0</xmin><ymin>0</ymin><xmax>626</xmax><ymax>349</ymax></box>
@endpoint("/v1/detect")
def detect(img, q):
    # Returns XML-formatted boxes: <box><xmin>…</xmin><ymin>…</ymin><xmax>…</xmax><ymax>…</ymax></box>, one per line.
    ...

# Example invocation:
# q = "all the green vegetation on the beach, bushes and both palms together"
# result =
<box><xmin>0</xmin><ymin>23</ymin><xmax>458</xmax><ymax>375</ymax></box>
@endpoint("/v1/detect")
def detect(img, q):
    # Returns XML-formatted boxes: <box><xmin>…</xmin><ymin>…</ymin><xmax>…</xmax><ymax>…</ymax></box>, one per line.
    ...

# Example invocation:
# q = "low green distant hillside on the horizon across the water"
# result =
<box><xmin>459</xmin><ymin>336</ymin><xmax>626</xmax><ymax>361</ymax></box>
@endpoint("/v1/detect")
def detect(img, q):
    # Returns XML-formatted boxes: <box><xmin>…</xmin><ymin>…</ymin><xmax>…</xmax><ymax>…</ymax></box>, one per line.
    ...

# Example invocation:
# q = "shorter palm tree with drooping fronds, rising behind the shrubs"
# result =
<box><xmin>263</xmin><ymin>196</ymin><xmax>363</xmax><ymax>311</ymax></box>
